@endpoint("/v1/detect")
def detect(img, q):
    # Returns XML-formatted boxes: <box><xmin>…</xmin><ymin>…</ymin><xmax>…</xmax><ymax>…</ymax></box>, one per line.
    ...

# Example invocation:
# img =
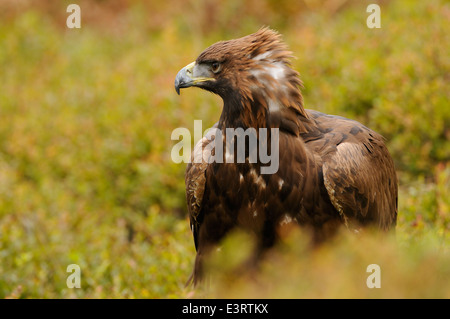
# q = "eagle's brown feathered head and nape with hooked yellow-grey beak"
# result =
<box><xmin>175</xmin><ymin>28</ymin><xmax>307</xmax><ymax>134</ymax></box>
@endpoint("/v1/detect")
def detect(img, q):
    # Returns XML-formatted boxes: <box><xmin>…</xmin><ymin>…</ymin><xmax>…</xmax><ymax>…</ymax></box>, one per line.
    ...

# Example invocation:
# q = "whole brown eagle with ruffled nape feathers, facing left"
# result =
<box><xmin>175</xmin><ymin>28</ymin><xmax>397</xmax><ymax>283</ymax></box>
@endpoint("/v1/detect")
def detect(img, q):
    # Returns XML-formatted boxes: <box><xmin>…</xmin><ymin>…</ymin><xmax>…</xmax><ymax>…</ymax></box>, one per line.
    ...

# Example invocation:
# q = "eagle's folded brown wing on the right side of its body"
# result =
<box><xmin>305</xmin><ymin>110</ymin><xmax>398</xmax><ymax>230</ymax></box>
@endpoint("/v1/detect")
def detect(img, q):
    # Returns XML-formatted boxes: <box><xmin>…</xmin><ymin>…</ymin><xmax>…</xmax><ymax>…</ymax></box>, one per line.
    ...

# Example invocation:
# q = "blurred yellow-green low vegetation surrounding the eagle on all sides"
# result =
<box><xmin>0</xmin><ymin>0</ymin><xmax>450</xmax><ymax>298</ymax></box>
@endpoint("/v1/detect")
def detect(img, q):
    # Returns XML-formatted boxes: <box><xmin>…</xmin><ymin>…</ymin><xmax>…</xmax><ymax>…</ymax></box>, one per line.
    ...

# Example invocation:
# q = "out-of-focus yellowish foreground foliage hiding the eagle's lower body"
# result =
<box><xmin>205</xmin><ymin>231</ymin><xmax>450</xmax><ymax>298</ymax></box>
